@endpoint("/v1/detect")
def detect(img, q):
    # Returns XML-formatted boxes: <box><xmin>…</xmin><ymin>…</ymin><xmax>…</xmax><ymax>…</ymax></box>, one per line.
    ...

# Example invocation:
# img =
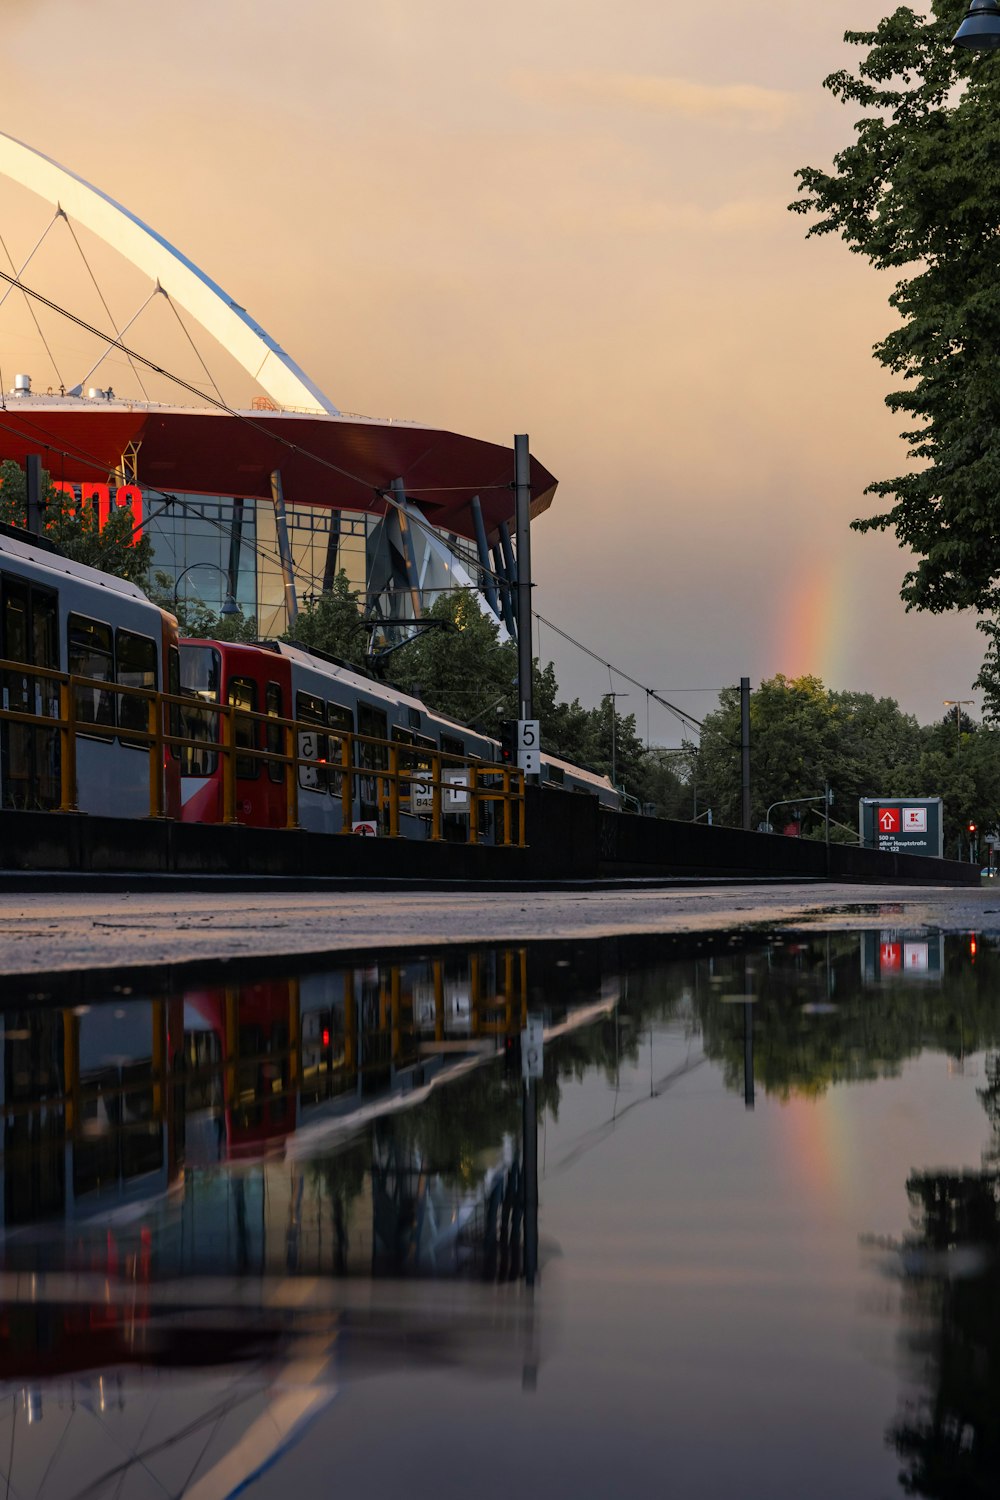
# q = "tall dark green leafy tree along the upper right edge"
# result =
<box><xmin>790</xmin><ymin>0</ymin><xmax>1000</xmax><ymax>681</ymax></box>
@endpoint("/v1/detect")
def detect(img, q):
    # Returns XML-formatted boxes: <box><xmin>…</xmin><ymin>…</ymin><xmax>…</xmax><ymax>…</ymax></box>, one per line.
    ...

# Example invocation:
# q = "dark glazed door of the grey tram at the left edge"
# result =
<box><xmin>0</xmin><ymin>578</ymin><xmax>60</xmax><ymax>810</ymax></box>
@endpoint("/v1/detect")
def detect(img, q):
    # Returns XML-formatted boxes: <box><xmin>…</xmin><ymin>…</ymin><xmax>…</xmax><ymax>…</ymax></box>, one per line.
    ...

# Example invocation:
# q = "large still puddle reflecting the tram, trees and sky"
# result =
<box><xmin>0</xmin><ymin>929</ymin><xmax>1000</xmax><ymax>1500</ymax></box>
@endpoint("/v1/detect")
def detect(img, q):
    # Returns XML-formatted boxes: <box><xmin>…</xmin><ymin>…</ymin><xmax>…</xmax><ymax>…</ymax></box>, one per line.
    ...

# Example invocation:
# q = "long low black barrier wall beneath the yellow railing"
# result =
<box><xmin>0</xmin><ymin>786</ymin><xmax>979</xmax><ymax>885</ymax></box>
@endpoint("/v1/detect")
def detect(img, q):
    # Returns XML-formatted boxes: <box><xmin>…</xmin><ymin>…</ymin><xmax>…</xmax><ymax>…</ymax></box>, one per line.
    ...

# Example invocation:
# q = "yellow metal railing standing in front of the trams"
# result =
<box><xmin>0</xmin><ymin>662</ymin><xmax>525</xmax><ymax>846</ymax></box>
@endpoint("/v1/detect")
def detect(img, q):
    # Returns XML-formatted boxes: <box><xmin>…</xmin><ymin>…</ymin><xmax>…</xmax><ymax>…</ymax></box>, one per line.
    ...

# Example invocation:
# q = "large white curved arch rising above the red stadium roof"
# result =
<box><xmin>0</xmin><ymin>132</ymin><xmax>339</xmax><ymax>417</ymax></box>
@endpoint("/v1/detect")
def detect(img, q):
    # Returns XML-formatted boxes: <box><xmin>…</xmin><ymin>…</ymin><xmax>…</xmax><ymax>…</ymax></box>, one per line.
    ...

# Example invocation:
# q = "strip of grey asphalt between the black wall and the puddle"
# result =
<box><xmin>0</xmin><ymin>879</ymin><xmax>1000</xmax><ymax>975</ymax></box>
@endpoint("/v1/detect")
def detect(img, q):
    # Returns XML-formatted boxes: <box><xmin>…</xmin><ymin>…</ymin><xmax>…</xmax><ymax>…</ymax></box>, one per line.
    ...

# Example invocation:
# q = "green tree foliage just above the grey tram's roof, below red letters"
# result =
<box><xmin>0</xmin><ymin>459</ymin><xmax>153</xmax><ymax>585</ymax></box>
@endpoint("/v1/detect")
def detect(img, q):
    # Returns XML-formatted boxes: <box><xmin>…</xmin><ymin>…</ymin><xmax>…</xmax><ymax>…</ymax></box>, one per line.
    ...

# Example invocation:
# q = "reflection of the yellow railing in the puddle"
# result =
<box><xmin>0</xmin><ymin>948</ymin><xmax>528</xmax><ymax>1176</ymax></box>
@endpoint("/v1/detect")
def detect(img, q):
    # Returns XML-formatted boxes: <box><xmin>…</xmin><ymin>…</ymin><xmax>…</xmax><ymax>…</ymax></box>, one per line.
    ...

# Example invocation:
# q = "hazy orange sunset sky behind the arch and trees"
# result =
<box><xmin>0</xmin><ymin>0</ymin><xmax>982</xmax><ymax>744</ymax></box>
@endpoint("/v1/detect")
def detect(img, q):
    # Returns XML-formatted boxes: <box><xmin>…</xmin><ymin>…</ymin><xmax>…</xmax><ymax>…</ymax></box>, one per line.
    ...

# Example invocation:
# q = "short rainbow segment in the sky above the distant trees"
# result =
<box><xmin>771</xmin><ymin>557</ymin><xmax>852</xmax><ymax>687</ymax></box>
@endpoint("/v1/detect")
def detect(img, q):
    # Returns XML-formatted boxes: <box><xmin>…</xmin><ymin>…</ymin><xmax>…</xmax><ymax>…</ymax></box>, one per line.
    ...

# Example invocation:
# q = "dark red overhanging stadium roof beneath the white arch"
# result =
<box><xmin>0</xmin><ymin>396</ymin><xmax>556</xmax><ymax>539</ymax></box>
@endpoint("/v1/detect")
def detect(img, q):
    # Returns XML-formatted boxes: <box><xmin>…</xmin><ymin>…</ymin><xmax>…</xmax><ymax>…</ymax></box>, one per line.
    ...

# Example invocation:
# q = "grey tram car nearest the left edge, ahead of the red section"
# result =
<box><xmin>0</xmin><ymin>527</ymin><xmax>180</xmax><ymax>818</ymax></box>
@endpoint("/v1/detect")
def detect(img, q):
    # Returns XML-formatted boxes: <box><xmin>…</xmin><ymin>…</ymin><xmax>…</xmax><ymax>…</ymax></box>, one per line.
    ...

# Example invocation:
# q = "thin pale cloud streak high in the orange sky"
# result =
<box><xmin>513</xmin><ymin>71</ymin><xmax>801</xmax><ymax>131</ymax></box>
